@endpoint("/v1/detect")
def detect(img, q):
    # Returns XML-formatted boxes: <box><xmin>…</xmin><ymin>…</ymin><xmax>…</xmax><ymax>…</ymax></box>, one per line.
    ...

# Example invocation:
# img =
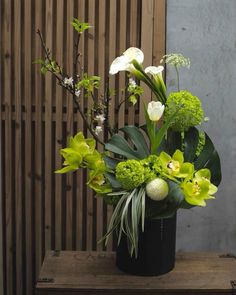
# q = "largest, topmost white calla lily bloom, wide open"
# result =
<box><xmin>109</xmin><ymin>47</ymin><xmax>144</xmax><ymax>75</ymax></box>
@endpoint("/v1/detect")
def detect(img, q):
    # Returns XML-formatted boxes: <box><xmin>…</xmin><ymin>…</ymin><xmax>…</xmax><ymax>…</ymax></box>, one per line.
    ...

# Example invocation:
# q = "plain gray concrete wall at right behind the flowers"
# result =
<box><xmin>167</xmin><ymin>0</ymin><xmax>236</xmax><ymax>254</ymax></box>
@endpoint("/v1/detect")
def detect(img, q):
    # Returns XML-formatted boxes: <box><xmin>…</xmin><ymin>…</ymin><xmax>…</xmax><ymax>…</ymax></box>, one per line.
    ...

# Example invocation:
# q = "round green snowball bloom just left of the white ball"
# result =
<box><xmin>116</xmin><ymin>160</ymin><xmax>144</xmax><ymax>190</ymax></box>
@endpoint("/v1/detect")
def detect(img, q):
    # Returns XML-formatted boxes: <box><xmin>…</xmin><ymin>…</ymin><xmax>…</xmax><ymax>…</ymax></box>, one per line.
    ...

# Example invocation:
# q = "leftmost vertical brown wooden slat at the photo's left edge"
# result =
<box><xmin>3</xmin><ymin>0</ymin><xmax>15</xmax><ymax>295</ymax></box>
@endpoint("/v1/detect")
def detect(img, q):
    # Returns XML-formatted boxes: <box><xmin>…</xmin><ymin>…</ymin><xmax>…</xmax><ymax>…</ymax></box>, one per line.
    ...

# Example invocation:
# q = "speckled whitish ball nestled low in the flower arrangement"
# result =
<box><xmin>146</xmin><ymin>178</ymin><xmax>169</xmax><ymax>201</ymax></box>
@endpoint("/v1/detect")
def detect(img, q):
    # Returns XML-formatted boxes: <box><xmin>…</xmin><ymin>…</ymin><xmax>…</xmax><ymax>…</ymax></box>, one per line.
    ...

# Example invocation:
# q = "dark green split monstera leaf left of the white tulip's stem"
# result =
<box><xmin>105</xmin><ymin>126</ymin><xmax>149</xmax><ymax>159</ymax></box>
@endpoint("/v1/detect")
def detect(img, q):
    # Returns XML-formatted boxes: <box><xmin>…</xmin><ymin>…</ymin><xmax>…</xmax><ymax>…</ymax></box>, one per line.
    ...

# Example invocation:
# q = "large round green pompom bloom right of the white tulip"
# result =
<box><xmin>164</xmin><ymin>90</ymin><xmax>204</xmax><ymax>132</ymax></box>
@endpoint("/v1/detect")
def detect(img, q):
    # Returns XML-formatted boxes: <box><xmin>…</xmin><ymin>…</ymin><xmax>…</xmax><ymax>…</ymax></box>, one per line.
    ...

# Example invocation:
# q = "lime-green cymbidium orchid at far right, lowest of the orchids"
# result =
<box><xmin>181</xmin><ymin>169</ymin><xmax>217</xmax><ymax>207</ymax></box>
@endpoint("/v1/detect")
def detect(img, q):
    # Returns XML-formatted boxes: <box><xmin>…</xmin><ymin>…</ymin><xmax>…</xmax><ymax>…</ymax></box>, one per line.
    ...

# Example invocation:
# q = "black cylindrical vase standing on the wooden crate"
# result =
<box><xmin>116</xmin><ymin>215</ymin><xmax>176</xmax><ymax>276</ymax></box>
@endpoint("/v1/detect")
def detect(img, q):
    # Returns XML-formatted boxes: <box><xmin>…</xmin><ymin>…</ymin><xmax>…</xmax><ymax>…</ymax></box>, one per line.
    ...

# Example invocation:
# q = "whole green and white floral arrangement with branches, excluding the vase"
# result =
<box><xmin>36</xmin><ymin>19</ymin><xmax>221</xmax><ymax>256</ymax></box>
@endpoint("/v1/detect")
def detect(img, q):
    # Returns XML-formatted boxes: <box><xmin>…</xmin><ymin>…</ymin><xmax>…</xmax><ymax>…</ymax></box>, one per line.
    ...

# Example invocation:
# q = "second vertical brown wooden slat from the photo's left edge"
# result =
<box><xmin>14</xmin><ymin>1</ymin><xmax>25</xmax><ymax>295</ymax></box>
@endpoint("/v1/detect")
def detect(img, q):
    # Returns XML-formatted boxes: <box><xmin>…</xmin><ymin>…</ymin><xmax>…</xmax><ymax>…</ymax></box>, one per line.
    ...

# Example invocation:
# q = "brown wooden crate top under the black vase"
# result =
<box><xmin>36</xmin><ymin>251</ymin><xmax>236</xmax><ymax>295</ymax></box>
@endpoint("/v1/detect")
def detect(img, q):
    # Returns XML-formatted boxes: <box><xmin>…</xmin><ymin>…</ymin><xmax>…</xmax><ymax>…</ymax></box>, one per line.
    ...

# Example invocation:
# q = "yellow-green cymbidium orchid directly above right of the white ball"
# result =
<box><xmin>160</xmin><ymin>150</ymin><xmax>194</xmax><ymax>178</ymax></box>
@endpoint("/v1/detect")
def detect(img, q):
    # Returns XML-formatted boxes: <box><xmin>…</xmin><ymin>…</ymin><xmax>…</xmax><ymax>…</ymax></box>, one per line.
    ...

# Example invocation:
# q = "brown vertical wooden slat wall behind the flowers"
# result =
<box><xmin>0</xmin><ymin>0</ymin><xmax>165</xmax><ymax>295</ymax></box>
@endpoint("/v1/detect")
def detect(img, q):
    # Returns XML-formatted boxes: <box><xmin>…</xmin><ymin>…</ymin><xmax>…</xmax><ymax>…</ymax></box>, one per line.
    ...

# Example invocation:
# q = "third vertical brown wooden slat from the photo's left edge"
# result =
<box><xmin>24</xmin><ymin>0</ymin><xmax>34</xmax><ymax>295</ymax></box>
